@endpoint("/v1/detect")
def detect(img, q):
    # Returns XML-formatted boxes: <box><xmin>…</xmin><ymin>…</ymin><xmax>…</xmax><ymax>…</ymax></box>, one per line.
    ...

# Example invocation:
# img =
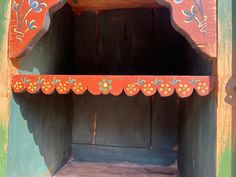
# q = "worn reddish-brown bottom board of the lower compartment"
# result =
<box><xmin>54</xmin><ymin>161</ymin><xmax>179</xmax><ymax>177</ymax></box>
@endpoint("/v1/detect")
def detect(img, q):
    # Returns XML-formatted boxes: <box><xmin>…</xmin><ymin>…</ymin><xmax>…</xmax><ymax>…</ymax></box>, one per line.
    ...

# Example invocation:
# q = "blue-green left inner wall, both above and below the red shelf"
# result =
<box><xmin>7</xmin><ymin>4</ymin><xmax>72</xmax><ymax>177</ymax></box>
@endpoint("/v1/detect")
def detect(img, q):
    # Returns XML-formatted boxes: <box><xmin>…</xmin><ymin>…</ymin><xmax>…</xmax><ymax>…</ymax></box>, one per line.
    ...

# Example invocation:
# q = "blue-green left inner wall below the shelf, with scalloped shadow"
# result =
<box><xmin>7</xmin><ymin>93</ymin><xmax>72</xmax><ymax>177</ymax></box>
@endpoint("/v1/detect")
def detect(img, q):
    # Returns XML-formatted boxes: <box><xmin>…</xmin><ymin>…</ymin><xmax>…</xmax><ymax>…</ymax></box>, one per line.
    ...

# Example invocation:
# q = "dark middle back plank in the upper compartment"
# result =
<box><xmin>98</xmin><ymin>9</ymin><xmax>152</xmax><ymax>75</ymax></box>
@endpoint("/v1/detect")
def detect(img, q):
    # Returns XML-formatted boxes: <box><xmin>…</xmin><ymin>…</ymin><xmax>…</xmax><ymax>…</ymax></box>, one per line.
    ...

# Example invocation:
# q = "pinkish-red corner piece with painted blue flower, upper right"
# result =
<box><xmin>156</xmin><ymin>0</ymin><xmax>217</xmax><ymax>58</ymax></box>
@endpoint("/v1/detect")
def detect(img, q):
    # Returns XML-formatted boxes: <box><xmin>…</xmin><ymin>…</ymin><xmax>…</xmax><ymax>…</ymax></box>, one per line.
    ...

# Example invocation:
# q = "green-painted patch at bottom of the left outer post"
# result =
<box><xmin>0</xmin><ymin>124</ymin><xmax>7</xmax><ymax>177</ymax></box>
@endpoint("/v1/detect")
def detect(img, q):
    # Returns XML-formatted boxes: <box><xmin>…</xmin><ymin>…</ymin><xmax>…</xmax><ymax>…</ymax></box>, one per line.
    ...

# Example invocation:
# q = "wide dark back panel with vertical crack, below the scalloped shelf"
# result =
<box><xmin>73</xmin><ymin>94</ymin><xmax>151</xmax><ymax>147</ymax></box>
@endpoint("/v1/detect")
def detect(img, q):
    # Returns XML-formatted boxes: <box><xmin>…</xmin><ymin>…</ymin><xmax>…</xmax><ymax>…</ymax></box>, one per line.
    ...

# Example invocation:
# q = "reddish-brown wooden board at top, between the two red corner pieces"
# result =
<box><xmin>67</xmin><ymin>0</ymin><xmax>161</xmax><ymax>14</ymax></box>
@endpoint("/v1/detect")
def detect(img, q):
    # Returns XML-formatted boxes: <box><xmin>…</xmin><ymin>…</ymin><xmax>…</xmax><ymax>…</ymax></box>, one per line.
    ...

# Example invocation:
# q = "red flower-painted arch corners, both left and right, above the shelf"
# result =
<box><xmin>9</xmin><ymin>0</ymin><xmax>217</xmax><ymax>58</ymax></box>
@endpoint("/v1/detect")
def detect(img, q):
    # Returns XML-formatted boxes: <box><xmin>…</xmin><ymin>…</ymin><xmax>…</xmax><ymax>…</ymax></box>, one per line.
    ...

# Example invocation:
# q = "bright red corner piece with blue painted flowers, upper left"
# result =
<box><xmin>9</xmin><ymin>0</ymin><xmax>64</xmax><ymax>58</ymax></box>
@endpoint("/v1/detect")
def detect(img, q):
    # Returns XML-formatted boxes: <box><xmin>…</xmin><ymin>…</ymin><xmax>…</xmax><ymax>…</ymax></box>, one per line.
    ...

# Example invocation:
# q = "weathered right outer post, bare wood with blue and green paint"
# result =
<box><xmin>216</xmin><ymin>0</ymin><xmax>236</xmax><ymax>177</ymax></box>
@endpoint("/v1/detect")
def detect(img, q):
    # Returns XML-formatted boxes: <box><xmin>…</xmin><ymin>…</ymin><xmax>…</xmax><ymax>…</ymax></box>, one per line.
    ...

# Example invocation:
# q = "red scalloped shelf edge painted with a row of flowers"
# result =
<box><xmin>11</xmin><ymin>75</ymin><xmax>214</xmax><ymax>98</ymax></box>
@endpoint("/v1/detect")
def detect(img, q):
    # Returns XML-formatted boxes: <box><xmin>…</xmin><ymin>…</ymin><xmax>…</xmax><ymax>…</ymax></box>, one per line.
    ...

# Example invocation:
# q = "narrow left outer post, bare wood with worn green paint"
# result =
<box><xmin>0</xmin><ymin>0</ymin><xmax>10</xmax><ymax>177</ymax></box>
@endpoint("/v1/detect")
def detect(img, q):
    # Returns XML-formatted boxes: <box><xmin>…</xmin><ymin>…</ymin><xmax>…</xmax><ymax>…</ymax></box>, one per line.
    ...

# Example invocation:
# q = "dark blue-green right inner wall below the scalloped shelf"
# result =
<box><xmin>178</xmin><ymin>93</ymin><xmax>216</xmax><ymax>177</ymax></box>
